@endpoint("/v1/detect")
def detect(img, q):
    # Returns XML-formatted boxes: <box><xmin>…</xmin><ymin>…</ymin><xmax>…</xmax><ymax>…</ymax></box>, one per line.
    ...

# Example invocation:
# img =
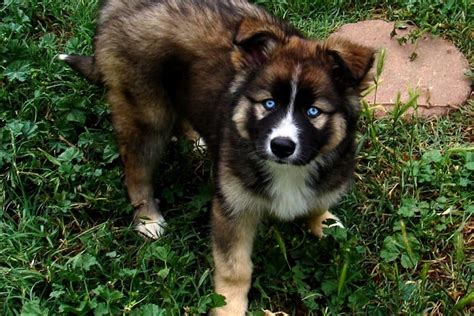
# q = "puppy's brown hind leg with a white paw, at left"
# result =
<box><xmin>108</xmin><ymin>89</ymin><xmax>175</xmax><ymax>239</ymax></box>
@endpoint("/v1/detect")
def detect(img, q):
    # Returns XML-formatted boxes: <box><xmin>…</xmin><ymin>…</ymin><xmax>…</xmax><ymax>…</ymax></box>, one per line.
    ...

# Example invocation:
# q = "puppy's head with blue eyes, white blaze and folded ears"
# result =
<box><xmin>231</xmin><ymin>20</ymin><xmax>374</xmax><ymax>165</ymax></box>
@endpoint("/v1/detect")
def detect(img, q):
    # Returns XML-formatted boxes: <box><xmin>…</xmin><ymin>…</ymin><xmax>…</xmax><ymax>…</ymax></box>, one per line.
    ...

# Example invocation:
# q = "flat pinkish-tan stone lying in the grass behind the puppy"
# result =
<box><xmin>331</xmin><ymin>20</ymin><xmax>471</xmax><ymax>117</ymax></box>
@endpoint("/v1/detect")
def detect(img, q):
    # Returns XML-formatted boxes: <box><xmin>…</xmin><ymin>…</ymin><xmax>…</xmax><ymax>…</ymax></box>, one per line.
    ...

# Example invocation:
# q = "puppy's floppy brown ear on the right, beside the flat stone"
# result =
<box><xmin>324</xmin><ymin>38</ymin><xmax>375</xmax><ymax>91</ymax></box>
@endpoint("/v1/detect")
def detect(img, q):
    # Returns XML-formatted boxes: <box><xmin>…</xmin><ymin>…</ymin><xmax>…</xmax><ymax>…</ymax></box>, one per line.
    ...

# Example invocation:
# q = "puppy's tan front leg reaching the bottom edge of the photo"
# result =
<box><xmin>211</xmin><ymin>199</ymin><xmax>259</xmax><ymax>316</ymax></box>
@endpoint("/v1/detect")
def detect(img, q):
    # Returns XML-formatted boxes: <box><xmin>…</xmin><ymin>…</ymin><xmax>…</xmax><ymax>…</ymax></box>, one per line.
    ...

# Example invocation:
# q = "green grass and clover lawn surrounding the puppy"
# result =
<box><xmin>0</xmin><ymin>0</ymin><xmax>474</xmax><ymax>315</ymax></box>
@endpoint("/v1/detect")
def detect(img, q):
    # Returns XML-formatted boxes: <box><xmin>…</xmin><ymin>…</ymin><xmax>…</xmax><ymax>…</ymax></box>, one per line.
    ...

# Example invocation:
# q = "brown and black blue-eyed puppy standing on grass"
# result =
<box><xmin>60</xmin><ymin>0</ymin><xmax>375</xmax><ymax>315</ymax></box>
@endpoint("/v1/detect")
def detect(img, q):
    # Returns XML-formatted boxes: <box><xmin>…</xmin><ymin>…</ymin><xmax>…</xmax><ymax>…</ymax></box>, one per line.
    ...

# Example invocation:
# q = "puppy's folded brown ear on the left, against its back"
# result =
<box><xmin>232</xmin><ymin>18</ymin><xmax>285</xmax><ymax>69</ymax></box>
